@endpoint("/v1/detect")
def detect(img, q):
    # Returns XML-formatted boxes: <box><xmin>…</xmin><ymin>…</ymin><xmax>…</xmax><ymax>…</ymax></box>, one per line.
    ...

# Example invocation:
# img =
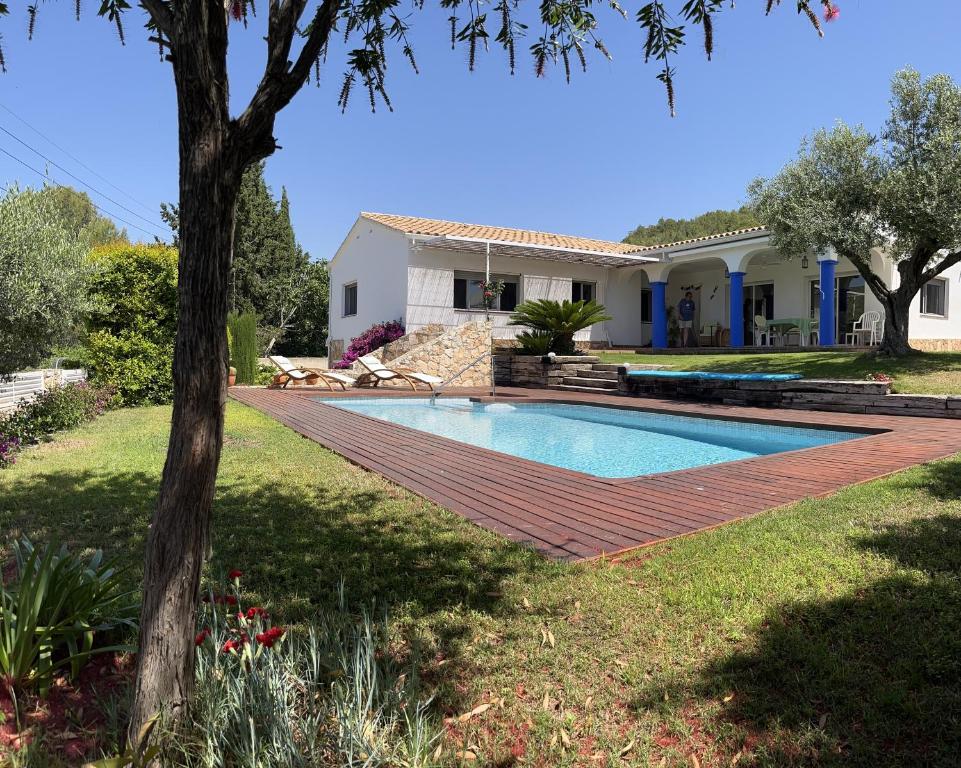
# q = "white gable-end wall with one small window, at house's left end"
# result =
<box><xmin>329</xmin><ymin>219</ymin><xmax>407</xmax><ymax>348</ymax></box>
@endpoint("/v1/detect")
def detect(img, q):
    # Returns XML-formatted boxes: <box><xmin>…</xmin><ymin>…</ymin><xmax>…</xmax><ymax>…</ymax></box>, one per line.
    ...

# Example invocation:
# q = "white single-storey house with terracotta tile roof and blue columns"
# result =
<box><xmin>329</xmin><ymin>213</ymin><xmax>961</xmax><ymax>359</ymax></box>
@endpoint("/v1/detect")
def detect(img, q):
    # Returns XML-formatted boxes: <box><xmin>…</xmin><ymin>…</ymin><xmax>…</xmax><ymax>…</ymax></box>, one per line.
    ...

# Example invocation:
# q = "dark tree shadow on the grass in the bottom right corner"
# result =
<box><xmin>637</xmin><ymin>515</ymin><xmax>961</xmax><ymax>767</ymax></box>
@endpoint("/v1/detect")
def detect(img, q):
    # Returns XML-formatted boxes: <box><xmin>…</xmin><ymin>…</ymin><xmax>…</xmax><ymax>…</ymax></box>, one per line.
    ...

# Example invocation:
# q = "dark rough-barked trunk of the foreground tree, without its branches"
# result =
<box><xmin>129</xmin><ymin>0</ymin><xmax>242</xmax><ymax>739</ymax></box>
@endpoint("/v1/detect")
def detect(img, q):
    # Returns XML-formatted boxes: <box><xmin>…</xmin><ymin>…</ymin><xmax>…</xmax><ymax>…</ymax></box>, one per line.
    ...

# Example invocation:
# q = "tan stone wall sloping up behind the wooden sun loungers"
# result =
<box><xmin>354</xmin><ymin>320</ymin><xmax>493</xmax><ymax>387</ymax></box>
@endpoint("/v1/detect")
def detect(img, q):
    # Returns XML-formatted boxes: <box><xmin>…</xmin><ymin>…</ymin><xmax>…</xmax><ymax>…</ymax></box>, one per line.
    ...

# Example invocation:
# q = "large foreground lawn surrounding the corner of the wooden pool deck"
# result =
<box><xmin>0</xmin><ymin>403</ymin><xmax>961</xmax><ymax>768</ymax></box>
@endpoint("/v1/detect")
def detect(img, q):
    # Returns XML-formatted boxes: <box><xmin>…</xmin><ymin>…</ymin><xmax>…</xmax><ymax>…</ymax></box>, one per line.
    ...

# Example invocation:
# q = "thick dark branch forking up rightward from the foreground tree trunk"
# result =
<box><xmin>232</xmin><ymin>0</ymin><xmax>340</xmax><ymax>159</ymax></box>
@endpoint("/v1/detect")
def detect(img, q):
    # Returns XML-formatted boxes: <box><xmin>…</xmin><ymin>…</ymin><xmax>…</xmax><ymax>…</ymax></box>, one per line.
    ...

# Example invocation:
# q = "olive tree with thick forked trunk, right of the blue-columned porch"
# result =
<box><xmin>749</xmin><ymin>69</ymin><xmax>961</xmax><ymax>355</ymax></box>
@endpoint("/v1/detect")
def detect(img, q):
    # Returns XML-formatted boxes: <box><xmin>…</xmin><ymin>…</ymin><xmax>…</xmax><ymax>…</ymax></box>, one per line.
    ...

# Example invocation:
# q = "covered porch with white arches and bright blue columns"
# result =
<box><xmin>640</xmin><ymin>233</ymin><xmax>883</xmax><ymax>352</ymax></box>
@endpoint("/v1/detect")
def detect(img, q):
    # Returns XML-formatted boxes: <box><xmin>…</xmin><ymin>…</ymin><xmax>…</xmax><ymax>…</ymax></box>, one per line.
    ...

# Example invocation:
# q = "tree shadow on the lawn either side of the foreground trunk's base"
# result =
<box><xmin>0</xmin><ymin>462</ymin><xmax>556</xmax><ymax>704</ymax></box>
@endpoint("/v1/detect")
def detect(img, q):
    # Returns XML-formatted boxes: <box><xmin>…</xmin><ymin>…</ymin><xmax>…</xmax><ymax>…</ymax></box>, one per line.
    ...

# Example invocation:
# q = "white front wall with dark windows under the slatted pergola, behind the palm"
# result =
<box><xmin>407</xmin><ymin>246</ymin><xmax>624</xmax><ymax>342</ymax></box>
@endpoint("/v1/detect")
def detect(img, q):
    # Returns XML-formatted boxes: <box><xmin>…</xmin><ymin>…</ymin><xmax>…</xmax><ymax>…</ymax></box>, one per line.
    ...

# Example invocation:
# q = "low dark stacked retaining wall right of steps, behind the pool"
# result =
<box><xmin>618</xmin><ymin>366</ymin><xmax>961</xmax><ymax>419</ymax></box>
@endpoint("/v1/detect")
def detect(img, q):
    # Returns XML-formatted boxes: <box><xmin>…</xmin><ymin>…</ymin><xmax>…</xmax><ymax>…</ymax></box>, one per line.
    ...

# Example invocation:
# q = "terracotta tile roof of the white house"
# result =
<box><xmin>360</xmin><ymin>212</ymin><xmax>764</xmax><ymax>254</ymax></box>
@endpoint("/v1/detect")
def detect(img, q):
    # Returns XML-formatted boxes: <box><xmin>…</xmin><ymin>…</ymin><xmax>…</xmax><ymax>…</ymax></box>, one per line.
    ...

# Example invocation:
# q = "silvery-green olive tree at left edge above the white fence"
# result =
<box><xmin>0</xmin><ymin>188</ymin><xmax>88</xmax><ymax>376</ymax></box>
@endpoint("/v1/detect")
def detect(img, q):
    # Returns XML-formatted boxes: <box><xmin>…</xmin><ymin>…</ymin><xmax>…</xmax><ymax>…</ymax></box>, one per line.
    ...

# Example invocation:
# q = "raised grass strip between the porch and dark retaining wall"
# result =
<box><xmin>592</xmin><ymin>352</ymin><xmax>961</xmax><ymax>395</ymax></box>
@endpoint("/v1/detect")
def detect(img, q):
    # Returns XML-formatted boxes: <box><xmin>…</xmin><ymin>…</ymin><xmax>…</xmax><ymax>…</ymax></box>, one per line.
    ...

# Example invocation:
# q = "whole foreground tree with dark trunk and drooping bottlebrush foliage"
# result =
<box><xmin>0</xmin><ymin>0</ymin><xmax>834</xmax><ymax>733</ymax></box>
